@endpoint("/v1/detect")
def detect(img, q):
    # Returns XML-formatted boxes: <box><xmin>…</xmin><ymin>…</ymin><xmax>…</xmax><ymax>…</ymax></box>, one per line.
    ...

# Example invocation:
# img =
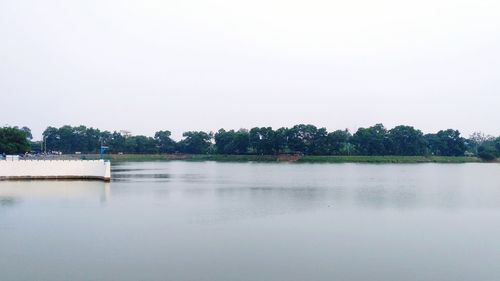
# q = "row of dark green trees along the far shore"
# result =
<box><xmin>0</xmin><ymin>124</ymin><xmax>500</xmax><ymax>160</ymax></box>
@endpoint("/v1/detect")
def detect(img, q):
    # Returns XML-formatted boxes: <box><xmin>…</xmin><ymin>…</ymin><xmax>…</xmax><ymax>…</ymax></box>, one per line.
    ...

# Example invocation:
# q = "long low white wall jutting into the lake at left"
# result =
<box><xmin>0</xmin><ymin>158</ymin><xmax>111</xmax><ymax>181</ymax></box>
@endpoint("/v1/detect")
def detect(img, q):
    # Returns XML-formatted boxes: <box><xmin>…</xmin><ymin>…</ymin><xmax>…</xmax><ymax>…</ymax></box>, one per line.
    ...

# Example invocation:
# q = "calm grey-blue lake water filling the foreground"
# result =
<box><xmin>0</xmin><ymin>162</ymin><xmax>500</xmax><ymax>281</ymax></box>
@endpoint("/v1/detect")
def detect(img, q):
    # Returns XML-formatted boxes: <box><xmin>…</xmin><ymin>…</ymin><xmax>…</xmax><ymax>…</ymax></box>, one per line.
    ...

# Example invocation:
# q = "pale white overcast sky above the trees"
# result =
<box><xmin>0</xmin><ymin>0</ymin><xmax>500</xmax><ymax>139</ymax></box>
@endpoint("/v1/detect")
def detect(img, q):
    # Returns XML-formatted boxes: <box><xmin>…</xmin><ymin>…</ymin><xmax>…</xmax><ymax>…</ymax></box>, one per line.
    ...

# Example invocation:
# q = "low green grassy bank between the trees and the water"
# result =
<box><xmin>84</xmin><ymin>154</ymin><xmax>481</xmax><ymax>163</ymax></box>
